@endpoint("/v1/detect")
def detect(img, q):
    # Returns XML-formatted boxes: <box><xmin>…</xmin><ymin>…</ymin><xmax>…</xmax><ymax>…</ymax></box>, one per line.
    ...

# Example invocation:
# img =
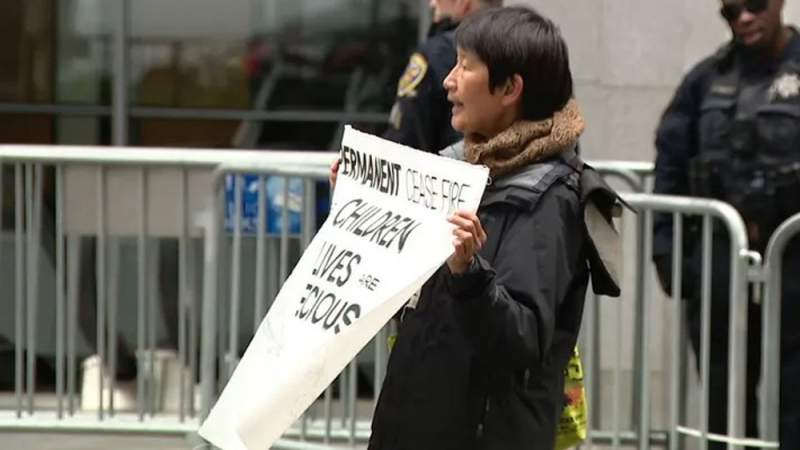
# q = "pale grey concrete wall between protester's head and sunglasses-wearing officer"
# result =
<box><xmin>505</xmin><ymin>0</ymin><xmax>800</xmax><ymax>161</ymax></box>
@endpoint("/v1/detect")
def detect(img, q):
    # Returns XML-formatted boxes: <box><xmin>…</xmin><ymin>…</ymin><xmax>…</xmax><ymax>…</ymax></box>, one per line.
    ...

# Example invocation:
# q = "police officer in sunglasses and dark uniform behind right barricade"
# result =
<box><xmin>654</xmin><ymin>0</ymin><xmax>800</xmax><ymax>449</ymax></box>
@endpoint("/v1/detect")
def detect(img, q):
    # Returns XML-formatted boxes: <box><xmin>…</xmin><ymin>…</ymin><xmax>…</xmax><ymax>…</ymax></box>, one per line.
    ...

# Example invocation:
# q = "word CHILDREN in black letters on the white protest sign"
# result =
<box><xmin>333</xmin><ymin>198</ymin><xmax>420</xmax><ymax>253</ymax></box>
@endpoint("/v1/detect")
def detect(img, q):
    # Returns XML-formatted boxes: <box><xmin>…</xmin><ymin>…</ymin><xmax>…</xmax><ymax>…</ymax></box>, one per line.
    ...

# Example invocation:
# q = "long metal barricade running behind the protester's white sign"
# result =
<box><xmin>0</xmin><ymin>146</ymin><xmax>680</xmax><ymax>448</ymax></box>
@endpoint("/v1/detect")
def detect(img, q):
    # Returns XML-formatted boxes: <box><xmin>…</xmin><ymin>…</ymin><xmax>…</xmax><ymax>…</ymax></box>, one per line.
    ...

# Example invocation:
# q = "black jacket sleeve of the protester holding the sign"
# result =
<box><xmin>448</xmin><ymin>187</ymin><xmax>588</xmax><ymax>368</ymax></box>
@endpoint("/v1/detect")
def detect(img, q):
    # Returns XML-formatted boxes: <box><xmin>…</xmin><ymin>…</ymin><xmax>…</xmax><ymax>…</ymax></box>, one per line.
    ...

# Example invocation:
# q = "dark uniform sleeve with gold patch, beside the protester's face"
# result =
<box><xmin>384</xmin><ymin>46</ymin><xmax>450</xmax><ymax>153</ymax></box>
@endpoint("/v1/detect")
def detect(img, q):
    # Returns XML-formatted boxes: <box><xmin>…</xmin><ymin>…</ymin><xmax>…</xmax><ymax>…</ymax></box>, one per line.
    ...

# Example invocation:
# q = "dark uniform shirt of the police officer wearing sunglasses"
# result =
<box><xmin>654</xmin><ymin>28</ymin><xmax>800</xmax><ymax>254</ymax></box>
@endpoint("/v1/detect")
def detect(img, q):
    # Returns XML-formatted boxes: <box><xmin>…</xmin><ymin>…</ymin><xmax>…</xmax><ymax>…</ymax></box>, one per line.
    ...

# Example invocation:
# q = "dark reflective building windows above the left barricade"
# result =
<box><xmin>0</xmin><ymin>0</ymin><xmax>427</xmax><ymax>149</ymax></box>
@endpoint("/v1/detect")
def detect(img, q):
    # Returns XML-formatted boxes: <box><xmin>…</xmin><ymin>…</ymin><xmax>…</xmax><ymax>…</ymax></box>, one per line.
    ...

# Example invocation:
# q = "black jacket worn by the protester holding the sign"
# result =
<box><xmin>369</xmin><ymin>153</ymin><xmax>618</xmax><ymax>450</ymax></box>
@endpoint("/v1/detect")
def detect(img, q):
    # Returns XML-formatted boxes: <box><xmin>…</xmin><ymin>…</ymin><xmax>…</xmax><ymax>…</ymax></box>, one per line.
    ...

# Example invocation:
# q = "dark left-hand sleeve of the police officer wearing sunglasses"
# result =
<box><xmin>653</xmin><ymin>60</ymin><xmax>713</xmax><ymax>293</ymax></box>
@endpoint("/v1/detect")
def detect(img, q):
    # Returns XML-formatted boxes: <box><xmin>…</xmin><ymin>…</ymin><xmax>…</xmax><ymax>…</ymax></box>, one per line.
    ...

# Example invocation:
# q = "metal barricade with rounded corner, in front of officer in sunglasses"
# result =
<box><xmin>590</xmin><ymin>194</ymin><xmax>770</xmax><ymax>449</ymax></box>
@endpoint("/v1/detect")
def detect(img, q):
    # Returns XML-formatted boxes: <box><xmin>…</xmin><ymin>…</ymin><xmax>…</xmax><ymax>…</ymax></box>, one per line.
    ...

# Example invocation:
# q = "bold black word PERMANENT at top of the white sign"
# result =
<box><xmin>340</xmin><ymin>146</ymin><xmax>400</xmax><ymax>196</ymax></box>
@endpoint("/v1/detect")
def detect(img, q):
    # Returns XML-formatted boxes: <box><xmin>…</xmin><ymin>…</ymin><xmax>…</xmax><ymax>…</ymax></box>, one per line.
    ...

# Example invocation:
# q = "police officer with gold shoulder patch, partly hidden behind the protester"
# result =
<box><xmin>384</xmin><ymin>0</ymin><xmax>502</xmax><ymax>153</ymax></box>
